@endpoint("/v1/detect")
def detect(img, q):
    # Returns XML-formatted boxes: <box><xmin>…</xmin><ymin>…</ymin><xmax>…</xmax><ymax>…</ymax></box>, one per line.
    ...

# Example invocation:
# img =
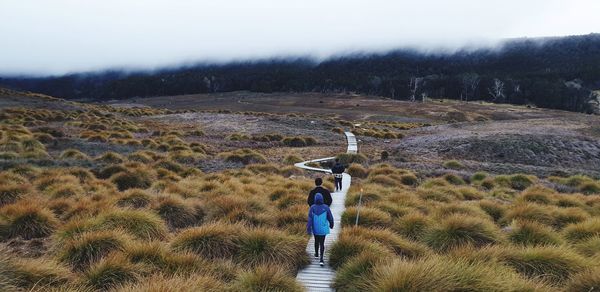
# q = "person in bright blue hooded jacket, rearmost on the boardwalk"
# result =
<box><xmin>306</xmin><ymin>193</ymin><xmax>333</xmax><ymax>267</ymax></box>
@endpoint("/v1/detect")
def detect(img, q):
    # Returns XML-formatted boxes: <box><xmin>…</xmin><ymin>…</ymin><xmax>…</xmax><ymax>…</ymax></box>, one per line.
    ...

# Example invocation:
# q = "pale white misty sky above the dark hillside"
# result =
<box><xmin>0</xmin><ymin>0</ymin><xmax>600</xmax><ymax>76</ymax></box>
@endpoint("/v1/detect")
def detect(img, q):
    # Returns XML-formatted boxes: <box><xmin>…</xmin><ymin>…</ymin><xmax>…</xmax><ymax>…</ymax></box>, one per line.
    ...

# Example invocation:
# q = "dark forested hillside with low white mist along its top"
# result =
<box><xmin>0</xmin><ymin>34</ymin><xmax>600</xmax><ymax>113</ymax></box>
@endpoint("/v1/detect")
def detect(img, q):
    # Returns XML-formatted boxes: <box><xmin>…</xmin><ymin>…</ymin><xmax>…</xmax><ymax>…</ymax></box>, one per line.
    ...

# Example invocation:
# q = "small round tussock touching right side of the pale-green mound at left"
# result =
<box><xmin>154</xmin><ymin>196</ymin><xmax>201</xmax><ymax>228</ymax></box>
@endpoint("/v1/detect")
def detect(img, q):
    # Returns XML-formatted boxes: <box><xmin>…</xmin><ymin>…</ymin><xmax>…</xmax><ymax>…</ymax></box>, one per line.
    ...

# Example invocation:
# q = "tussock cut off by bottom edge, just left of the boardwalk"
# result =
<box><xmin>231</xmin><ymin>266</ymin><xmax>304</xmax><ymax>292</ymax></box>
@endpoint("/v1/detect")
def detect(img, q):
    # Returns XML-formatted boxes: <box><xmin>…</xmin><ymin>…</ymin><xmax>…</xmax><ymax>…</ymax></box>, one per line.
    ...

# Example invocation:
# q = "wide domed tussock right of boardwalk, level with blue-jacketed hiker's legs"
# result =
<box><xmin>423</xmin><ymin>215</ymin><xmax>502</xmax><ymax>251</ymax></box>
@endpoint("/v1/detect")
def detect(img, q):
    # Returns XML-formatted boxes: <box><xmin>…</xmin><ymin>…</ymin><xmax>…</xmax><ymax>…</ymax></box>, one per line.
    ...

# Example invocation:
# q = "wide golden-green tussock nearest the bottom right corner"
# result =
<box><xmin>503</xmin><ymin>246</ymin><xmax>589</xmax><ymax>284</ymax></box>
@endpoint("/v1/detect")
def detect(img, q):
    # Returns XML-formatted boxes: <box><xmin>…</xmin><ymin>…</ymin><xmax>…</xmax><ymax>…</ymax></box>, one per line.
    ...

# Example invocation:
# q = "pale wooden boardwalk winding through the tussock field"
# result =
<box><xmin>295</xmin><ymin>132</ymin><xmax>358</xmax><ymax>291</ymax></box>
